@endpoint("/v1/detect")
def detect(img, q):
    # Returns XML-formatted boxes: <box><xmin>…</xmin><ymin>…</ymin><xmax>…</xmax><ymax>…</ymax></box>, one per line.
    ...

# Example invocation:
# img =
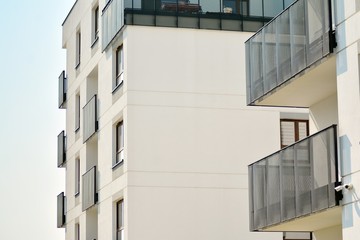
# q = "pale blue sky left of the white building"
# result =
<box><xmin>0</xmin><ymin>0</ymin><xmax>75</xmax><ymax>240</ymax></box>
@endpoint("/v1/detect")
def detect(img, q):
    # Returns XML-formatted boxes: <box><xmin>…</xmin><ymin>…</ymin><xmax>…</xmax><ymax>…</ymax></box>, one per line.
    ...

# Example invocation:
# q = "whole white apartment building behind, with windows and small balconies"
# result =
<box><xmin>57</xmin><ymin>0</ymin><xmax>308</xmax><ymax>240</ymax></box>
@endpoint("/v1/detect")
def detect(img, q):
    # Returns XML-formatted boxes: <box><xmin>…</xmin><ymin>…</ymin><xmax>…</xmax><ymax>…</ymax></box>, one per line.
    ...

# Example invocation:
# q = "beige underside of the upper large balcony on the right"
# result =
<box><xmin>255</xmin><ymin>56</ymin><xmax>336</xmax><ymax>107</ymax></box>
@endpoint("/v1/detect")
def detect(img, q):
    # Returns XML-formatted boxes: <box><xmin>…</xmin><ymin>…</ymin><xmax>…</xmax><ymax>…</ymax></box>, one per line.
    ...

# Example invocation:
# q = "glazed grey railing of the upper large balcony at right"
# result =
<box><xmin>245</xmin><ymin>0</ymin><xmax>336</xmax><ymax>104</ymax></box>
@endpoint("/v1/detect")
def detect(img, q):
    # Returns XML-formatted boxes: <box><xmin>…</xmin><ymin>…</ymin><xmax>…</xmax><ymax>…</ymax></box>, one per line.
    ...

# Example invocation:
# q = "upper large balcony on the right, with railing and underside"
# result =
<box><xmin>245</xmin><ymin>0</ymin><xmax>336</xmax><ymax>107</ymax></box>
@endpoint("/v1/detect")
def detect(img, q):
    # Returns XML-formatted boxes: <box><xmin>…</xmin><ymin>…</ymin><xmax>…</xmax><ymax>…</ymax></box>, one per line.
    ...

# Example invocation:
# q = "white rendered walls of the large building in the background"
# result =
<box><xmin>59</xmin><ymin>0</ymin><xmax>304</xmax><ymax>240</ymax></box>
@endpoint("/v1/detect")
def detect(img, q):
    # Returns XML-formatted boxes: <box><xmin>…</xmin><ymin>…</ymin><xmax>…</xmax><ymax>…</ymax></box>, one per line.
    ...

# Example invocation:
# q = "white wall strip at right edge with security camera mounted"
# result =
<box><xmin>336</xmin><ymin>0</ymin><xmax>360</xmax><ymax>240</ymax></box>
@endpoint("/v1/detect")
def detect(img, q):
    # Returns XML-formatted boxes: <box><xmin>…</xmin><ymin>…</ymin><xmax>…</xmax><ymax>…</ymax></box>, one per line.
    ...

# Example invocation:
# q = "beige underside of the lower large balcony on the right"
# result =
<box><xmin>260</xmin><ymin>206</ymin><xmax>342</xmax><ymax>232</ymax></box>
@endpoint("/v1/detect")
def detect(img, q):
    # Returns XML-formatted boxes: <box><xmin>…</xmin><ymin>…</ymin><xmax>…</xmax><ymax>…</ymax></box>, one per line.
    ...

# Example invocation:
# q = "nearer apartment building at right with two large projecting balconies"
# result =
<box><xmin>246</xmin><ymin>0</ymin><xmax>360</xmax><ymax>240</ymax></box>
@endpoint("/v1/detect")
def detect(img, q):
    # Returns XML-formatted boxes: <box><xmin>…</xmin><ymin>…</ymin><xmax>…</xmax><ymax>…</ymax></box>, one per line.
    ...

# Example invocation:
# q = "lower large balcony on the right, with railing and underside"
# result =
<box><xmin>249</xmin><ymin>125</ymin><xmax>341</xmax><ymax>232</ymax></box>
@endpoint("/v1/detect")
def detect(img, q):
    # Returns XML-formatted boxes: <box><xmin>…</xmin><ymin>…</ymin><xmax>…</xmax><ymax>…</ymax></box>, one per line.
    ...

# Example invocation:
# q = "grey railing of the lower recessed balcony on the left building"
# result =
<box><xmin>82</xmin><ymin>166</ymin><xmax>97</xmax><ymax>211</ymax></box>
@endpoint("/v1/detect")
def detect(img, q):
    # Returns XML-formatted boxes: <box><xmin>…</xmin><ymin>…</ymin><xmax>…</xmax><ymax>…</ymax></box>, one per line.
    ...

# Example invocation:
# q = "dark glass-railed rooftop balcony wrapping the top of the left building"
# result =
<box><xmin>102</xmin><ymin>0</ymin><xmax>294</xmax><ymax>50</ymax></box>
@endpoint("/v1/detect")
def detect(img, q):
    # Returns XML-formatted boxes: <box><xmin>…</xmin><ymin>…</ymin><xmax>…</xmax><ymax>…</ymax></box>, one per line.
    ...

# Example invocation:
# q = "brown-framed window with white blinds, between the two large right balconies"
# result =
<box><xmin>280</xmin><ymin>119</ymin><xmax>309</xmax><ymax>148</ymax></box>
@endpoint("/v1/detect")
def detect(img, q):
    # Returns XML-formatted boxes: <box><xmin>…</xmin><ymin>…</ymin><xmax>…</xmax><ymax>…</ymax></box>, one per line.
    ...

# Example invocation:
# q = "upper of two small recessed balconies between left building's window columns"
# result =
<box><xmin>83</xmin><ymin>94</ymin><xmax>98</xmax><ymax>143</ymax></box>
